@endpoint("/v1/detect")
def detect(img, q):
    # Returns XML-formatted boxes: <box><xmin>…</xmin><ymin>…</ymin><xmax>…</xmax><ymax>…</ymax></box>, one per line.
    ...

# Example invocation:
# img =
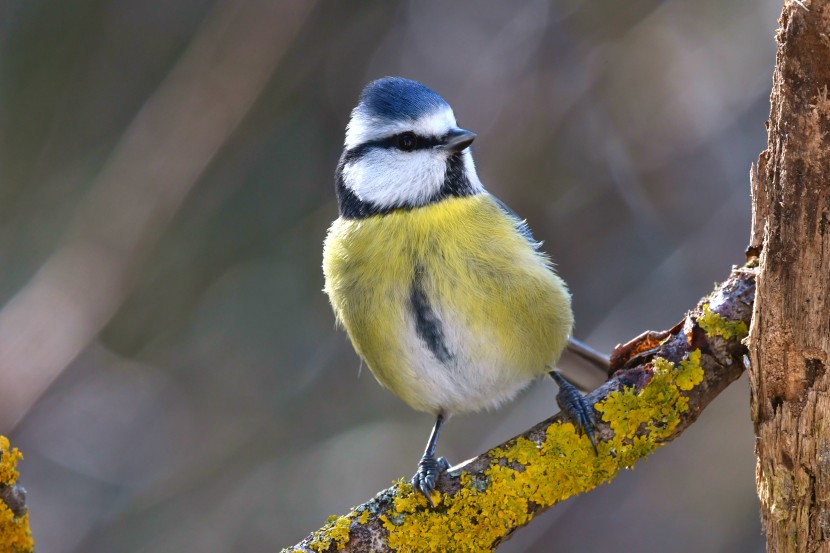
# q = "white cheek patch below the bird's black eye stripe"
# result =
<box><xmin>343</xmin><ymin>148</ymin><xmax>447</xmax><ymax>208</ymax></box>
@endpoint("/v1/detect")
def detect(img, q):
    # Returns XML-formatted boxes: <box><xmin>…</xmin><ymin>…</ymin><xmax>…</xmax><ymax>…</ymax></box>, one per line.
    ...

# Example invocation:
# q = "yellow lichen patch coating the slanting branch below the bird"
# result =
<box><xmin>381</xmin><ymin>350</ymin><xmax>703</xmax><ymax>553</ymax></box>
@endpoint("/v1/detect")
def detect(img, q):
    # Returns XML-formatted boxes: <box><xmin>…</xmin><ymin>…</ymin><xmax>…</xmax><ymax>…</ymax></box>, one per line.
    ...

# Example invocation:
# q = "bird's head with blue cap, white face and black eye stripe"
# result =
<box><xmin>336</xmin><ymin>77</ymin><xmax>483</xmax><ymax>217</ymax></box>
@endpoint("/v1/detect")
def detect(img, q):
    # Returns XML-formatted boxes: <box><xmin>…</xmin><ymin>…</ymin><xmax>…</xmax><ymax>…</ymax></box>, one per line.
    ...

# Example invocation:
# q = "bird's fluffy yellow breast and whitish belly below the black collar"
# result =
<box><xmin>323</xmin><ymin>193</ymin><xmax>573</xmax><ymax>413</ymax></box>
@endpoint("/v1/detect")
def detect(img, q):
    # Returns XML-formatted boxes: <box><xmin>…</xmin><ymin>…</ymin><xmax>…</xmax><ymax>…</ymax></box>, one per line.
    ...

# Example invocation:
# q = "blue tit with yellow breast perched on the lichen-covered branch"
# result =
<box><xmin>323</xmin><ymin>77</ymin><xmax>596</xmax><ymax>504</ymax></box>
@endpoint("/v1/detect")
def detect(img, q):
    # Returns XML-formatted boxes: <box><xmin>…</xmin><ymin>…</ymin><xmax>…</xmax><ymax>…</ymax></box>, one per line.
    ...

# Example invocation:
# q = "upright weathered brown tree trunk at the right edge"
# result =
<box><xmin>749</xmin><ymin>0</ymin><xmax>830</xmax><ymax>552</ymax></box>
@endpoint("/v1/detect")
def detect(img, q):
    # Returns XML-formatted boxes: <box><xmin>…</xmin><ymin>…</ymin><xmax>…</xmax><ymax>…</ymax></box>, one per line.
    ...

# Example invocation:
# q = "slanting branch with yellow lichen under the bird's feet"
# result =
<box><xmin>284</xmin><ymin>267</ymin><xmax>755</xmax><ymax>553</ymax></box>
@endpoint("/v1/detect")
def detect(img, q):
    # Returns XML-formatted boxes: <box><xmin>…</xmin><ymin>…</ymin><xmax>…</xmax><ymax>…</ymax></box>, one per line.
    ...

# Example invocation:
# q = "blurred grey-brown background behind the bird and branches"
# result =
<box><xmin>0</xmin><ymin>0</ymin><xmax>781</xmax><ymax>553</ymax></box>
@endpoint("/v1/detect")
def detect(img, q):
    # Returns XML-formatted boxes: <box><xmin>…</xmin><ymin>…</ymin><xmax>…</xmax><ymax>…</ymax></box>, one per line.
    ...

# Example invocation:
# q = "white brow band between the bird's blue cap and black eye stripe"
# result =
<box><xmin>346</xmin><ymin>106</ymin><xmax>457</xmax><ymax>149</ymax></box>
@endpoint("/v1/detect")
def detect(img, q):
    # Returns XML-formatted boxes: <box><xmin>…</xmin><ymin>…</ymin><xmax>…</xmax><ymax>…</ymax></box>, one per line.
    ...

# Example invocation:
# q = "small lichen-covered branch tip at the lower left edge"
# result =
<box><xmin>0</xmin><ymin>436</ymin><xmax>35</xmax><ymax>553</ymax></box>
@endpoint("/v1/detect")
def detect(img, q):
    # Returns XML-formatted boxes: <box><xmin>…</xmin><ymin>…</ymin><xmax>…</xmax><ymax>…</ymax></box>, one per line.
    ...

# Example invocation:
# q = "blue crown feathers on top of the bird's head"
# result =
<box><xmin>357</xmin><ymin>77</ymin><xmax>449</xmax><ymax>120</ymax></box>
